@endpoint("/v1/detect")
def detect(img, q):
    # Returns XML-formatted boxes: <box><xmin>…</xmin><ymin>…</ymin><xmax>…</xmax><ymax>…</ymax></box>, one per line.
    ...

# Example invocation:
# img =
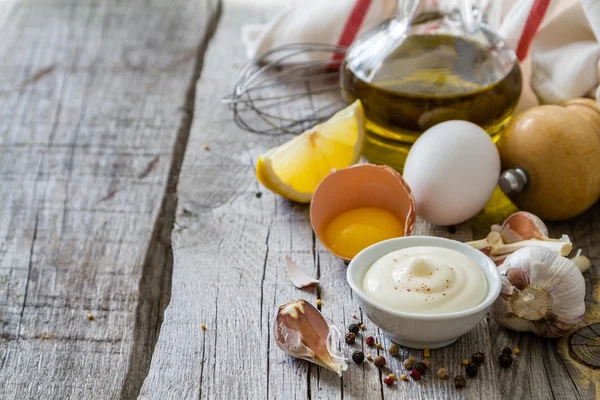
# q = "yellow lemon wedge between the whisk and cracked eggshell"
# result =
<box><xmin>256</xmin><ymin>100</ymin><xmax>365</xmax><ymax>203</ymax></box>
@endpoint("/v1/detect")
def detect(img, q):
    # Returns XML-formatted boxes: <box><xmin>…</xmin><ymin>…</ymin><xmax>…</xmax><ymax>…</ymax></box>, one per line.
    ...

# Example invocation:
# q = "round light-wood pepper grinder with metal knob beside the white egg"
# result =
<box><xmin>498</xmin><ymin>98</ymin><xmax>600</xmax><ymax>221</ymax></box>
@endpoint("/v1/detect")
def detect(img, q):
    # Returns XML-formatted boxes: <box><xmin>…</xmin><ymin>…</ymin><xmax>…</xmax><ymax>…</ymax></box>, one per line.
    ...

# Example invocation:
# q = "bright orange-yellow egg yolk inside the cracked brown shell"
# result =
<box><xmin>325</xmin><ymin>207</ymin><xmax>404</xmax><ymax>258</ymax></box>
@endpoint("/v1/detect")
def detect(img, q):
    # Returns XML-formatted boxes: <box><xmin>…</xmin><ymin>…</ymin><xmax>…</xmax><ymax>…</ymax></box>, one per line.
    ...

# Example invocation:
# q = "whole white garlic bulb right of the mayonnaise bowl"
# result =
<box><xmin>490</xmin><ymin>246</ymin><xmax>585</xmax><ymax>338</ymax></box>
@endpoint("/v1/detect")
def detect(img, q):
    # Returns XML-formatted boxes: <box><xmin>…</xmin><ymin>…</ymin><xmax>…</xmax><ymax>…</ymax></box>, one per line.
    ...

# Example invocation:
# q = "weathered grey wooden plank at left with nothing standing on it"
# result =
<box><xmin>0</xmin><ymin>0</ymin><xmax>213</xmax><ymax>400</ymax></box>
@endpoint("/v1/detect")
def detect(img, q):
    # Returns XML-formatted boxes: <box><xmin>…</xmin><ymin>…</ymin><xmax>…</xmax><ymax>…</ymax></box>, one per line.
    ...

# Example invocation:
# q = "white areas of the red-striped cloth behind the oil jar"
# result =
<box><xmin>242</xmin><ymin>0</ymin><xmax>600</xmax><ymax>110</ymax></box>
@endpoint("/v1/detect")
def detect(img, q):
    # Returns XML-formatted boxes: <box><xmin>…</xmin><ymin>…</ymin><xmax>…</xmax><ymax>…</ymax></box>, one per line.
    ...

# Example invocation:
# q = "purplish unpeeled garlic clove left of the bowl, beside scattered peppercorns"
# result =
<box><xmin>273</xmin><ymin>300</ymin><xmax>348</xmax><ymax>376</ymax></box>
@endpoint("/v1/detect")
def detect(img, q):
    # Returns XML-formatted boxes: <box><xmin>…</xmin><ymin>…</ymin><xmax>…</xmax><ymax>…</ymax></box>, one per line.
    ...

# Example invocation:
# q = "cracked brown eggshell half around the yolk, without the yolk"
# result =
<box><xmin>310</xmin><ymin>164</ymin><xmax>416</xmax><ymax>261</ymax></box>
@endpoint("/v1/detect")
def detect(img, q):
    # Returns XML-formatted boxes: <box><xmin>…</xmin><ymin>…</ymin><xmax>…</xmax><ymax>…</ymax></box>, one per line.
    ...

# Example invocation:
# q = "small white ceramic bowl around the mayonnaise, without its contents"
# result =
<box><xmin>346</xmin><ymin>236</ymin><xmax>501</xmax><ymax>349</ymax></box>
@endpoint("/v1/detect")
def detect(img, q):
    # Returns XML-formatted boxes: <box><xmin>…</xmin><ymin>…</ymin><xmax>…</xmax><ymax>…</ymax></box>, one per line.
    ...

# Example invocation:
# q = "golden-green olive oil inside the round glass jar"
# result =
<box><xmin>341</xmin><ymin>34</ymin><xmax>521</xmax><ymax>171</ymax></box>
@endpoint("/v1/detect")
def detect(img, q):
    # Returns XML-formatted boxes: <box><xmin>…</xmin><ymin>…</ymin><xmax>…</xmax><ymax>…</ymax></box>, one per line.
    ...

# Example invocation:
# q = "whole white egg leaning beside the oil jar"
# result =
<box><xmin>403</xmin><ymin>121</ymin><xmax>500</xmax><ymax>225</ymax></box>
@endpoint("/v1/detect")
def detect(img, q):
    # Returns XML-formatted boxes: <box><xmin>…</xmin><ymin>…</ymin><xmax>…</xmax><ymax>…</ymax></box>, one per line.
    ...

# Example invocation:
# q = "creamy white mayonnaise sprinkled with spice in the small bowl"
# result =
<box><xmin>362</xmin><ymin>246</ymin><xmax>488</xmax><ymax>314</ymax></box>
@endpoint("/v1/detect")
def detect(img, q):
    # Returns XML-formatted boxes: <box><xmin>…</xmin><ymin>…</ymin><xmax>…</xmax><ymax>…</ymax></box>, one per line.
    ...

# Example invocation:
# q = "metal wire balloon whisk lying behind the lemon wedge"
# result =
<box><xmin>222</xmin><ymin>43</ymin><xmax>346</xmax><ymax>135</ymax></box>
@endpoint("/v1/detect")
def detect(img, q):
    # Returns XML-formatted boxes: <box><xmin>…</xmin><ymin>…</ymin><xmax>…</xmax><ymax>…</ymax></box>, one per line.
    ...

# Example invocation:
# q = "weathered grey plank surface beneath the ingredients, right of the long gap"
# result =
<box><xmin>140</xmin><ymin>1</ymin><xmax>600</xmax><ymax>399</ymax></box>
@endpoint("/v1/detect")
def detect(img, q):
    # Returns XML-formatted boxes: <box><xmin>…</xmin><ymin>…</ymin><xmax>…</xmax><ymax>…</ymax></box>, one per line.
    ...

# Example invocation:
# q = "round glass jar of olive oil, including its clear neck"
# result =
<box><xmin>341</xmin><ymin>0</ymin><xmax>521</xmax><ymax>171</ymax></box>
